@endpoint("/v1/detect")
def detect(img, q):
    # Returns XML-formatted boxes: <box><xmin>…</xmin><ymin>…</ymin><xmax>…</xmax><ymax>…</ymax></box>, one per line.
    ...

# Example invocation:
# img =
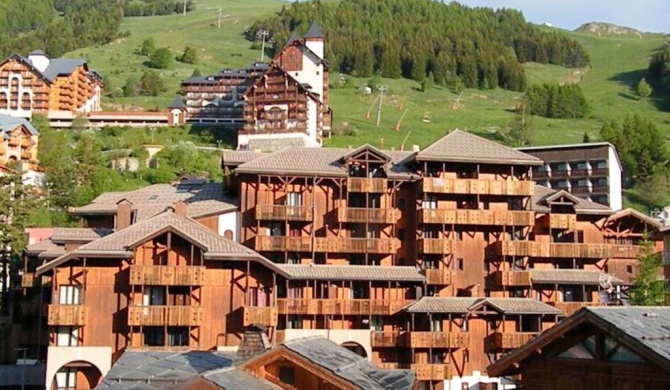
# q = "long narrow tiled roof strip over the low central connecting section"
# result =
<box><xmin>277</xmin><ymin>264</ymin><xmax>425</xmax><ymax>282</ymax></box>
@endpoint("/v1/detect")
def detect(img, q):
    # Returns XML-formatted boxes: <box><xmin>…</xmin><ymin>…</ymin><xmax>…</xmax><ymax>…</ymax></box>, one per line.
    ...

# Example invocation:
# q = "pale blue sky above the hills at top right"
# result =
<box><xmin>458</xmin><ymin>0</ymin><xmax>670</xmax><ymax>32</ymax></box>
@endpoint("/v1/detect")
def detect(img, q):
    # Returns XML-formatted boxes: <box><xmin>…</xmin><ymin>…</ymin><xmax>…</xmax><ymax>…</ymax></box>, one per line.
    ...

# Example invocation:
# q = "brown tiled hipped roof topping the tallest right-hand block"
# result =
<box><xmin>416</xmin><ymin>130</ymin><xmax>542</xmax><ymax>165</ymax></box>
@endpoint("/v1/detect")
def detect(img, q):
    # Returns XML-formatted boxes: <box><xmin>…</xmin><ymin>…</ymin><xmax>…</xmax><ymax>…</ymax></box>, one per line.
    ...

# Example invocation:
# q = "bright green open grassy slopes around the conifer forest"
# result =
<box><xmin>68</xmin><ymin>0</ymin><xmax>670</xmax><ymax>148</ymax></box>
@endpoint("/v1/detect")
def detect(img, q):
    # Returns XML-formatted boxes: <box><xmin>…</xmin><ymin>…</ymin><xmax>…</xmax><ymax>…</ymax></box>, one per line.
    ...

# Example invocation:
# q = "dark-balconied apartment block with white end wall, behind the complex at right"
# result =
<box><xmin>518</xmin><ymin>142</ymin><xmax>623</xmax><ymax>210</ymax></box>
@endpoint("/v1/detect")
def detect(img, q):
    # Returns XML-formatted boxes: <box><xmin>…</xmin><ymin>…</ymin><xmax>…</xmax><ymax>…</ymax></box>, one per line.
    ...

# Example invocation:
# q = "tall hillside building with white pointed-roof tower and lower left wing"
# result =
<box><xmin>182</xmin><ymin>24</ymin><xmax>332</xmax><ymax>150</ymax></box>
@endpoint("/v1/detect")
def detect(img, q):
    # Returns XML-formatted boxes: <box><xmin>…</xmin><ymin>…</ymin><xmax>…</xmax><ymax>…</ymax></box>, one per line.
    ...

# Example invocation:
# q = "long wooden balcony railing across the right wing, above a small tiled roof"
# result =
<box><xmin>491</xmin><ymin>241</ymin><xmax>640</xmax><ymax>259</ymax></box>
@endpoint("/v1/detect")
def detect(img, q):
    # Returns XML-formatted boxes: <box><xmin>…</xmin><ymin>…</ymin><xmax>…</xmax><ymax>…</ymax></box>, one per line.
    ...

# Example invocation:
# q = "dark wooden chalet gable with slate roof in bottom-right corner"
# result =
<box><xmin>488</xmin><ymin>307</ymin><xmax>670</xmax><ymax>390</ymax></box>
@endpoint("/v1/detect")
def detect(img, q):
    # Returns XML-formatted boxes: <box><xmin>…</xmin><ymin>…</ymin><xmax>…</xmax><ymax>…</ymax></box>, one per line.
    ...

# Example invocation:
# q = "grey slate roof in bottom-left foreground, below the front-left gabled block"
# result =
<box><xmin>95</xmin><ymin>351</ymin><xmax>233</xmax><ymax>390</ymax></box>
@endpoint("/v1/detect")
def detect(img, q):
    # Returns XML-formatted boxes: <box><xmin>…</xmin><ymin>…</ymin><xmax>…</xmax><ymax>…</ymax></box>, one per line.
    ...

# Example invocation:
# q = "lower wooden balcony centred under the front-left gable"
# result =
<box><xmin>128</xmin><ymin>306</ymin><xmax>202</xmax><ymax>326</ymax></box>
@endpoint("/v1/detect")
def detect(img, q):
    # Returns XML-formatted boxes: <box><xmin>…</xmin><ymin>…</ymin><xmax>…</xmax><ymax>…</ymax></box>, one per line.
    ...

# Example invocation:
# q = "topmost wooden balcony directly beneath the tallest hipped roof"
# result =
<box><xmin>422</xmin><ymin>177</ymin><xmax>535</xmax><ymax>196</ymax></box>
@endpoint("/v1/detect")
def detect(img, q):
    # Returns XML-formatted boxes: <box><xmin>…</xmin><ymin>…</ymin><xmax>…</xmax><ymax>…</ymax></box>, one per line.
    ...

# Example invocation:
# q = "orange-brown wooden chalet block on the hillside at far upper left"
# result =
<box><xmin>0</xmin><ymin>50</ymin><xmax>102</xmax><ymax>118</ymax></box>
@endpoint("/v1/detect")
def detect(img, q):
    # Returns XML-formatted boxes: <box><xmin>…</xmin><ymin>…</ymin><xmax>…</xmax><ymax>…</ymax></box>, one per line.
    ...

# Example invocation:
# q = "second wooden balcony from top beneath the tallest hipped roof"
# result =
<box><xmin>419</xmin><ymin>209</ymin><xmax>535</xmax><ymax>226</ymax></box>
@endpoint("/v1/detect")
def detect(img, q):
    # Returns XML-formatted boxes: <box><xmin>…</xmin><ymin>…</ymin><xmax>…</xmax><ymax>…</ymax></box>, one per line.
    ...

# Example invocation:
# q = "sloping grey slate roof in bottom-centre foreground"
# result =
<box><xmin>282</xmin><ymin>337</ymin><xmax>414</xmax><ymax>390</ymax></box>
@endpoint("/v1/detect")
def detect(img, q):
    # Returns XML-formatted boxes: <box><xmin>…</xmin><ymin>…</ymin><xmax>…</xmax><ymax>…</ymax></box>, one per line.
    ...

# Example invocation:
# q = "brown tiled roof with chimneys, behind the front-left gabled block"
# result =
<box><xmin>71</xmin><ymin>183</ymin><xmax>237</xmax><ymax>222</ymax></box>
